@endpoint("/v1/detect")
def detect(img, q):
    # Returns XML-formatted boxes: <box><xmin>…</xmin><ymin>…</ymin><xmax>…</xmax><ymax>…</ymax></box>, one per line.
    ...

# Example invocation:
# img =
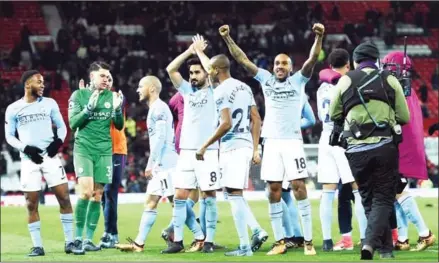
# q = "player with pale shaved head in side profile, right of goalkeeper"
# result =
<box><xmin>116</xmin><ymin>76</ymin><xmax>178</xmax><ymax>252</ymax></box>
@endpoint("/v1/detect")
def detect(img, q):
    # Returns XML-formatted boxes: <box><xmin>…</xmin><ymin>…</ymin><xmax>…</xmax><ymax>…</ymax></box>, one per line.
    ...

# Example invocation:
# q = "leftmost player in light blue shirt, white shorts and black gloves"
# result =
<box><xmin>5</xmin><ymin>70</ymin><xmax>75</xmax><ymax>257</ymax></box>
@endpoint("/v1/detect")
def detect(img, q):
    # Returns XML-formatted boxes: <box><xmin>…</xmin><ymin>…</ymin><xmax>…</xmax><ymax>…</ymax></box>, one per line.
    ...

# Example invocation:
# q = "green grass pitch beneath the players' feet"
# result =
<box><xmin>1</xmin><ymin>198</ymin><xmax>439</xmax><ymax>262</ymax></box>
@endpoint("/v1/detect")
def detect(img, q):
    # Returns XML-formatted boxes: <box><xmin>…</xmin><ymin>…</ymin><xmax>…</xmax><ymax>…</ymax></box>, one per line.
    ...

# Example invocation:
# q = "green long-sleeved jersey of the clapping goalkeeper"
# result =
<box><xmin>69</xmin><ymin>89</ymin><xmax>124</xmax><ymax>155</ymax></box>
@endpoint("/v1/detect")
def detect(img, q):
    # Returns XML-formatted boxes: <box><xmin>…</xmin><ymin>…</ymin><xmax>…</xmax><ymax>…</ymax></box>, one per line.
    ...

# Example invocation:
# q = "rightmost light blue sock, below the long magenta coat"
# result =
<box><xmin>398</xmin><ymin>194</ymin><xmax>430</xmax><ymax>237</ymax></box>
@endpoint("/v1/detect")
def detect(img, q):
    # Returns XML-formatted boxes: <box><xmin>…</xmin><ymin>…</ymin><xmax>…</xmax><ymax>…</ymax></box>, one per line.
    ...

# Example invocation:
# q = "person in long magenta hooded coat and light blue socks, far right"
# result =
<box><xmin>382</xmin><ymin>51</ymin><xmax>436</xmax><ymax>251</ymax></box>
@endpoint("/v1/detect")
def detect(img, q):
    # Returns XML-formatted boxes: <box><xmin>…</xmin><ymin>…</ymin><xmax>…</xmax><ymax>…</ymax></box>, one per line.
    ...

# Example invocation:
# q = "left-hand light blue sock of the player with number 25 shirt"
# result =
<box><xmin>228</xmin><ymin>194</ymin><xmax>250</xmax><ymax>248</ymax></box>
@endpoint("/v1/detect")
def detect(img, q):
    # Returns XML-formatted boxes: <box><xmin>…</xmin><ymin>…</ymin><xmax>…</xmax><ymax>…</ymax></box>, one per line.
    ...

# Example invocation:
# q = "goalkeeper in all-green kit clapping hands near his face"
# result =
<box><xmin>69</xmin><ymin>62</ymin><xmax>124</xmax><ymax>254</ymax></box>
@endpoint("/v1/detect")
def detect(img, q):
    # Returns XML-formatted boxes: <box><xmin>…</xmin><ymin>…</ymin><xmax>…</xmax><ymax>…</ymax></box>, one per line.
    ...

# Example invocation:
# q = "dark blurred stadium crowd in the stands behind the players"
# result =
<box><xmin>0</xmin><ymin>2</ymin><xmax>439</xmax><ymax>195</ymax></box>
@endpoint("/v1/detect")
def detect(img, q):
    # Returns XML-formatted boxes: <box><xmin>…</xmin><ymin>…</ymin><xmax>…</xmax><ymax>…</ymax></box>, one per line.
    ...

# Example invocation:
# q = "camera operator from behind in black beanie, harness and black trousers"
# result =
<box><xmin>329</xmin><ymin>42</ymin><xmax>410</xmax><ymax>259</ymax></box>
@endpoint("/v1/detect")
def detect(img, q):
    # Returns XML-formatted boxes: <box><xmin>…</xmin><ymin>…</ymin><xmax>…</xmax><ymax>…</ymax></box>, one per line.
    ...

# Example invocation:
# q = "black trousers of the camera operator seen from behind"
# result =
<box><xmin>346</xmin><ymin>142</ymin><xmax>399</xmax><ymax>253</ymax></box>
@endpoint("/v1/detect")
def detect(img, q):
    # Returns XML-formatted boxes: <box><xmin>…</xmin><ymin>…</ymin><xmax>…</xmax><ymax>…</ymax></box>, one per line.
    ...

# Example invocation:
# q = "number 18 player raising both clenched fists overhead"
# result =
<box><xmin>219</xmin><ymin>24</ymin><xmax>325</xmax><ymax>255</ymax></box>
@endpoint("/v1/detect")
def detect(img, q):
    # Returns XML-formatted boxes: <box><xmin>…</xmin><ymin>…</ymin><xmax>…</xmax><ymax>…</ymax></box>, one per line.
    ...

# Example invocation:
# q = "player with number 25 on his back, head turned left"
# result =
<box><xmin>193</xmin><ymin>35</ymin><xmax>268</xmax><ymax>256</ymax></box>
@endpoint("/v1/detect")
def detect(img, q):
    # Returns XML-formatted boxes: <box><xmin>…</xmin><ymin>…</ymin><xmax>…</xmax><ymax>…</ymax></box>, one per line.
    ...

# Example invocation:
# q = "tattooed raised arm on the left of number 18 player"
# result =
<box><xmin>219</xmin><ymin>25</ymin><xmax>258</xmax><ymax>77</ymax></box>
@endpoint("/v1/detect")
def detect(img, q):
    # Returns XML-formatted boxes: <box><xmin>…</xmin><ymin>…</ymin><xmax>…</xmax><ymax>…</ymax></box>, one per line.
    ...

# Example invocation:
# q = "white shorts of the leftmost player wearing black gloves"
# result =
<box><xmin>20</xmin><ymin>155</ymin><xmax>68</xmax><ymax>192</ymax></box>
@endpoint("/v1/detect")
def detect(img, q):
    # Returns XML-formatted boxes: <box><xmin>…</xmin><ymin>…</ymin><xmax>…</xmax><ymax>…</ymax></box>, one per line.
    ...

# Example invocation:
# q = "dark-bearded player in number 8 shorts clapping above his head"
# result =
<box><xmin>162</xmin><ymin>41</ymin><xmax>220</xmax><ymax>253</ymax></box>
